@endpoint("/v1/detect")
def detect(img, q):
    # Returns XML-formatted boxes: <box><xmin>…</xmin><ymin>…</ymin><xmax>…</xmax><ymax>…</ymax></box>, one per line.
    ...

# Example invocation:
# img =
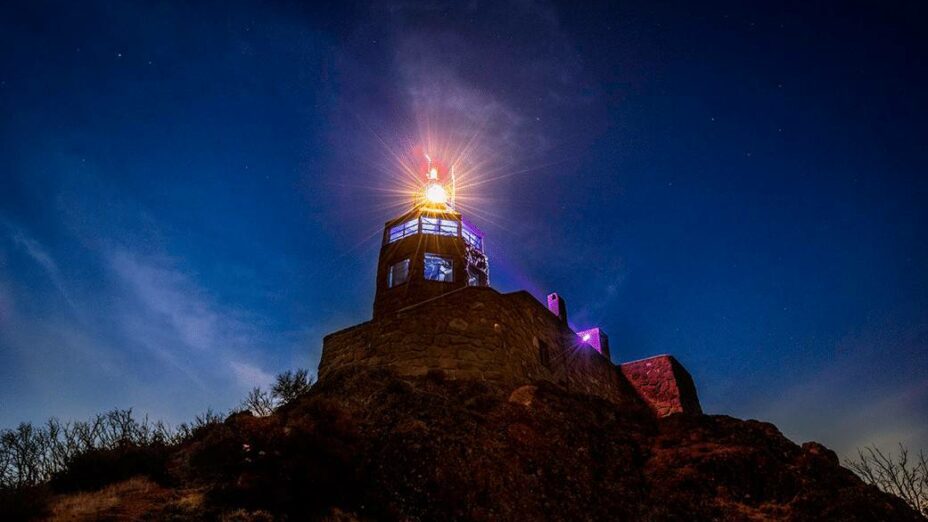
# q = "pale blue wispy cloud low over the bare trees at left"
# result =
<box><xmin>0</xmin><ymin>223</ymin><xmax>289</xmax><ymax>425</ymax></box>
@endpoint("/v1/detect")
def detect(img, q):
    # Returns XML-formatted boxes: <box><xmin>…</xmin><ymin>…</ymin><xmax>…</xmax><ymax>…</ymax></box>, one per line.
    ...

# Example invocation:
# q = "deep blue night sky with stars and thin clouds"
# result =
<box><xmin>0</xmin><ymin>0</ymin><xmax>928</xmax><ymax>455</ymax></box>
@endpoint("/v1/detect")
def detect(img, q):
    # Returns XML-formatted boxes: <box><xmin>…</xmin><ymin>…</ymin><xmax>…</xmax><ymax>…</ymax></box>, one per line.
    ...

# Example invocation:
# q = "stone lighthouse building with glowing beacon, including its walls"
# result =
<box><xmin>318</xmin><ymin>162</ymin><xmax>701</xmax><ymax>416</ymax></box>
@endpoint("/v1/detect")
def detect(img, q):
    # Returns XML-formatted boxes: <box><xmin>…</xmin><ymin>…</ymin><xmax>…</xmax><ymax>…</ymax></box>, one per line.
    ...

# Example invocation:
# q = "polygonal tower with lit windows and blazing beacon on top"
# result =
<box><xmin>374</xmin><ymin>168</ymin><xmax>489</xmax><ymax>318</ymax></box>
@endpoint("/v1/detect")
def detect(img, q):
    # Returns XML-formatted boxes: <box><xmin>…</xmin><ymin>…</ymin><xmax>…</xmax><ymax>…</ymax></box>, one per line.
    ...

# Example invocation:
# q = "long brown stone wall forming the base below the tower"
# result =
<box><xmin>319</xmin><ymin>287</ymin><xmax>698</xmax><ymax>414</ymax></box>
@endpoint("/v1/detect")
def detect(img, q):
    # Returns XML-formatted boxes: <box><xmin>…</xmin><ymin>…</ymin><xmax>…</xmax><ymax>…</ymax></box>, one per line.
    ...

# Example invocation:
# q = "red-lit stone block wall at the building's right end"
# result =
<box><xmin>619</xmin><ymin>355</ymin><xmax>702</xmax><ymax>417</ymax></box>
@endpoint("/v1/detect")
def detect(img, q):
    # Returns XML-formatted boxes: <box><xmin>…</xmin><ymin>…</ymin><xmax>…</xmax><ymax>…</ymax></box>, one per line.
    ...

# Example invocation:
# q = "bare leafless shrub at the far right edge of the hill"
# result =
<box><xmin>845</xmin><ymin>444</ymin><xmax>928</xmax><ymax>516</ymax></box>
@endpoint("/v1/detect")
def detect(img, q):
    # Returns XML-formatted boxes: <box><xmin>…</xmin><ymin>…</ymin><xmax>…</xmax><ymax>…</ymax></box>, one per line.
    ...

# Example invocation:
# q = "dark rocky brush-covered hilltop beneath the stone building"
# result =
<box><xmin>25</xmin><ymin>370</ymin><xmax>923</xmax><ymax>521</ymax></box>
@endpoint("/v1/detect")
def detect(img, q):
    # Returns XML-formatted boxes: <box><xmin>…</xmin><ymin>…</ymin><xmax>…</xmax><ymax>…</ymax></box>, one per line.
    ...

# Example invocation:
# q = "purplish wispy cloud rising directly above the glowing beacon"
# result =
<box><xmin>376</xmin><ymin>2</ymin><xmax>586</xmax><ymax>158</ymax></box>
